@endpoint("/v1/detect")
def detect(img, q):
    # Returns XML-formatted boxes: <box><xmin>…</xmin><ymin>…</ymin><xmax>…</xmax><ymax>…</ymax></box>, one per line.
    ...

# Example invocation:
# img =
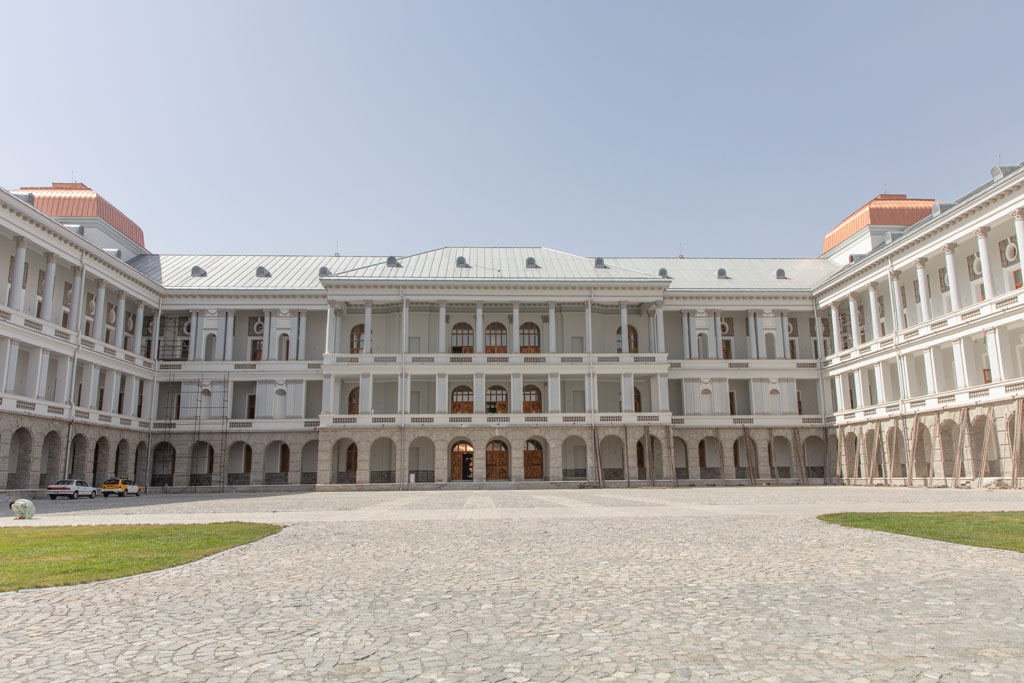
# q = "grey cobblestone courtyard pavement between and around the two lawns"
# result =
<box><xmin>0</xmin><ymin>487</ymin><xmax>1024</xmax><ymax>681</ymax></box>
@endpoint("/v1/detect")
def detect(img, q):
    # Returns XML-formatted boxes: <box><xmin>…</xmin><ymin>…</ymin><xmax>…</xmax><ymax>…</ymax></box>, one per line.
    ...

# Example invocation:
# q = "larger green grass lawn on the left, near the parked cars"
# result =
<box><xmin>0</xmin><ymin>522</ymin><xmax>281</xmax><ymax>592</ymax></box>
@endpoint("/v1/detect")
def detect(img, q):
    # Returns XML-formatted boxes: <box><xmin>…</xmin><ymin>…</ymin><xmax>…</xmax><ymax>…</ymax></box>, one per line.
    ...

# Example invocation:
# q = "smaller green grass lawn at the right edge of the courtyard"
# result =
<box><xmin>818</xmin><ymin>512</ymin><xmax>1024</xmax><ymax>552</ymax></box>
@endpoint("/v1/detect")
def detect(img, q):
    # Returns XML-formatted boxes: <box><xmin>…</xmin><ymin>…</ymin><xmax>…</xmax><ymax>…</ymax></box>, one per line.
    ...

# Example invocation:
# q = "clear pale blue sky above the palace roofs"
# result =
<box><xmin>0</xmin><ymin>0</ymin><xmax>1024</xmax><ymax>256</ymax></box>
